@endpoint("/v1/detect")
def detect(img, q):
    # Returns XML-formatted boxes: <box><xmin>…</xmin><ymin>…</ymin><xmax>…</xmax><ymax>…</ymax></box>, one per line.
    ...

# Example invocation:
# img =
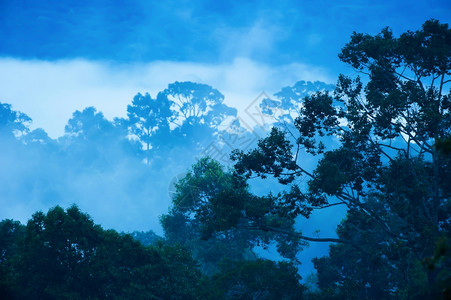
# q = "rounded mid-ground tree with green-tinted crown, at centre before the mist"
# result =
<box><xmin>160</xmin><ymin>158</ymin><xmax>266</xmax><ymax>274</ymax></box>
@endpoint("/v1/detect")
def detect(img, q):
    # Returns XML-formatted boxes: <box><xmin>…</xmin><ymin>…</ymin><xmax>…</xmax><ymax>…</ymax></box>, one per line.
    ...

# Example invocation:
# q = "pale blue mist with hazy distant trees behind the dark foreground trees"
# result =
<box><xmin>0</xmin><ymin>81</ymin><xmax>343</xmax><ymax>282</ymax></box>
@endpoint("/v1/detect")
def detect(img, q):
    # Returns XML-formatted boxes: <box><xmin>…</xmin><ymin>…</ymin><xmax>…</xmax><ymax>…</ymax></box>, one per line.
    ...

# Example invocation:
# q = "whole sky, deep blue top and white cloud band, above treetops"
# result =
<box><xmin>0</xmin><ymin>0</ymin><xmax>451</xmax><ymax>137</ymax></box>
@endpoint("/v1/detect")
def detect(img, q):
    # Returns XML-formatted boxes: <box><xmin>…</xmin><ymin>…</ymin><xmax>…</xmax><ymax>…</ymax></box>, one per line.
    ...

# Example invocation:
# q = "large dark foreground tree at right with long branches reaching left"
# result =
<box><xmin>171</xmin><ymin>20</ymin><xmax>451</xmax><ymax>299</ymax></box>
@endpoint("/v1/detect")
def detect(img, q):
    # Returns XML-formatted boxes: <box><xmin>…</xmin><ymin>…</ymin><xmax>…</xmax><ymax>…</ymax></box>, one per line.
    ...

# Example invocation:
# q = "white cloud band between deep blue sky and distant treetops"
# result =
<box><xmin>0</xmin><ymin>58</ymin><xmax>334</xmax><ymax>138</ymax></box>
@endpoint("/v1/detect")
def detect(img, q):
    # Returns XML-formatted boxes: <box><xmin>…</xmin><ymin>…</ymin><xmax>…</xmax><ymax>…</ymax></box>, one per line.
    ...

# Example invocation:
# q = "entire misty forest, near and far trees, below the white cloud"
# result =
<box><xmin>0</xmin><ymin>20</ymin><xmax>451</xmax><ymax>299</ymax></box>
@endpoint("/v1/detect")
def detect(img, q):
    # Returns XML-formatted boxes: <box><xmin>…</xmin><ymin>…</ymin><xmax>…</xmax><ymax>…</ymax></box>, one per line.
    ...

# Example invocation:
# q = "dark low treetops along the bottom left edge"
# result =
<box><xmin>0</xmin><ymin>206</ymin><xmax>304</xmax><ymax>299</ymax></box>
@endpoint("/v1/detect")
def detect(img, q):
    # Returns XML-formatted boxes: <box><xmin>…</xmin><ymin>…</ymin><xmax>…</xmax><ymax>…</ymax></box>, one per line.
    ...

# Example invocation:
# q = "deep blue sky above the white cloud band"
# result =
<box><xmin>0</xmin><ymin>0</ymin><xmax>451</xmax><ymax>69</ymax></box>
